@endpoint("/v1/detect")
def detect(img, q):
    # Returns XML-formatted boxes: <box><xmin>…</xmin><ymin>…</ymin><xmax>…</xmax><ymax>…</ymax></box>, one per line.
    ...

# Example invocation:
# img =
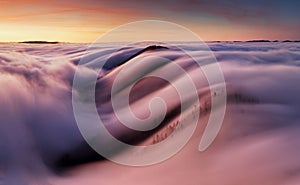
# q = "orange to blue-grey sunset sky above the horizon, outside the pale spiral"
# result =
<box><xmin>0</xmin><ymin>0</ymin><xmax>300</xmax><ymax>42</ymax></box>
